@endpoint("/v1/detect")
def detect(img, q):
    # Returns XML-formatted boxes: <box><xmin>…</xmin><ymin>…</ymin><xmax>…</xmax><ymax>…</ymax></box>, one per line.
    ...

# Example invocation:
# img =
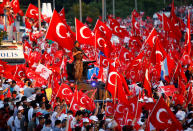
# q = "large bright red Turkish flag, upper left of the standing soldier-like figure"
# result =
<box><xmin>46</xmin><ymin>10</ymin><xmax>74</xmax><ymax>50</ymax></box>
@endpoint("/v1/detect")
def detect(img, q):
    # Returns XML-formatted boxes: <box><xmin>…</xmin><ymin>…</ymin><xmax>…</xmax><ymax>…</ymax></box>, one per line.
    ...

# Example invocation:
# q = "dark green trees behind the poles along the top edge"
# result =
<box><xmin>19</xmin><ymin>0</ymin><xmax>193</xmax><ymax>24</ymax></box>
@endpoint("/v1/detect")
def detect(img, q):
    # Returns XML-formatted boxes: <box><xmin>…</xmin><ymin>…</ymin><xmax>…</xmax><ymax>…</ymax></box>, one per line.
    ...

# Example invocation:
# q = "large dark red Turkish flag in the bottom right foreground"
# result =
<box><xmin>149</xmin><ymin>97</ymin><xmax>182</xmax><ymax>130</ymax></box>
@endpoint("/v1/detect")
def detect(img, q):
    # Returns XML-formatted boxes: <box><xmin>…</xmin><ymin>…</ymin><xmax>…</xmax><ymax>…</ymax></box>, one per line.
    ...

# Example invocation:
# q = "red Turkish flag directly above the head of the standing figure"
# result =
<box><xmin>75</xmin><ymin>19</ymin><xmax>95</xmax><ymax>46</ymax></box>
